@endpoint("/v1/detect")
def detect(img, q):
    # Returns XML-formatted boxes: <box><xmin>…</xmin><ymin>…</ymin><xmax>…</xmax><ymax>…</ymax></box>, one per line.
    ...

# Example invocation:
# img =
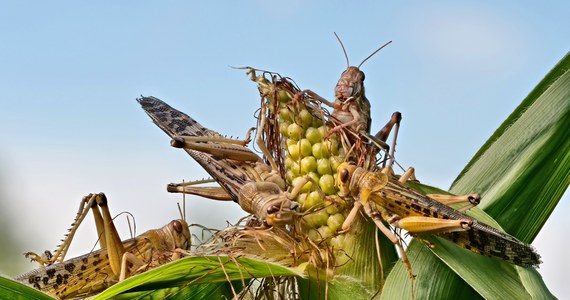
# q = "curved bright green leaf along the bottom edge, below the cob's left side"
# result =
<box><xmin>95</xmin><ymin>256</ymin><xmax>302</xmax><ymax>299</ymax></box>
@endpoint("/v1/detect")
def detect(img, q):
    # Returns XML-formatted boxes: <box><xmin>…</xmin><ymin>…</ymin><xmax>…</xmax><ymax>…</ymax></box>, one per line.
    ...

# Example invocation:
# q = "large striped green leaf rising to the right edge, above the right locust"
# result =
<box><xmin>451</xmin><ymin>54</ymin><xmax>570</xmax><ymax>243</ymax></box>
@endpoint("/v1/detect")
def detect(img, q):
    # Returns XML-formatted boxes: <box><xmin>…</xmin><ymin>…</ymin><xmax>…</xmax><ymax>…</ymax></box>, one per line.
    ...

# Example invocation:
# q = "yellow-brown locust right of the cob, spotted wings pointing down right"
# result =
<box><xmin>337</xmin><ymin>163</ymin><xmax>540</xmax><ymax>279</ymax></box>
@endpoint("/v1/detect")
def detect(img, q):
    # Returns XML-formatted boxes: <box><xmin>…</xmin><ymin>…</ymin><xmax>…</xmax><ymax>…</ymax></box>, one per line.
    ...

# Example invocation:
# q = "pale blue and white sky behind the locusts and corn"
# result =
<box><xmin>0</xmin><ymin>1</ymin><xmax>570</xmax><ymax>298</ymax></box>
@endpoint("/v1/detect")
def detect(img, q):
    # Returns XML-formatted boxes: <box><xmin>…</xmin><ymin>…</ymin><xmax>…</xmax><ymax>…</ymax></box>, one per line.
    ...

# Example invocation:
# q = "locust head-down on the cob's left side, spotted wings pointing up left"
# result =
<box><xmin>138</xmin><ymin>97</ymin><xmax>310</xmax><ymax>226</ymax></box>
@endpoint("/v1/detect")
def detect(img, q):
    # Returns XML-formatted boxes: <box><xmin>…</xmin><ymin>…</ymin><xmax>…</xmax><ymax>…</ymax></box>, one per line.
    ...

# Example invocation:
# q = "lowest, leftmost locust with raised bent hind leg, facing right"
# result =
<box><xmin>15</xmin><ymin>193</ymin><xmax>190</xmax><ymax>298</ymax></box>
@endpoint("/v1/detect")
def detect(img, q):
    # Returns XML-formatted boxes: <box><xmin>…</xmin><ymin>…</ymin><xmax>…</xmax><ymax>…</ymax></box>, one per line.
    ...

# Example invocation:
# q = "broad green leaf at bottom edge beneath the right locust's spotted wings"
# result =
<box><xmin>381</xmin><ymin>237</ymin><xmax>554</xmax><ymax>299</ymax></box>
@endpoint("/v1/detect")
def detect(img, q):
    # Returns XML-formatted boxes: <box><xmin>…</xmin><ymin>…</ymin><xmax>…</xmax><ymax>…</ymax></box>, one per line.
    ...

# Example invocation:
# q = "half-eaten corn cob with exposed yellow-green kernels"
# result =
<box><xmin>245</xmin><ymin>69</ymin><xmax>382</xmax><ymax>266</ymax></box>
